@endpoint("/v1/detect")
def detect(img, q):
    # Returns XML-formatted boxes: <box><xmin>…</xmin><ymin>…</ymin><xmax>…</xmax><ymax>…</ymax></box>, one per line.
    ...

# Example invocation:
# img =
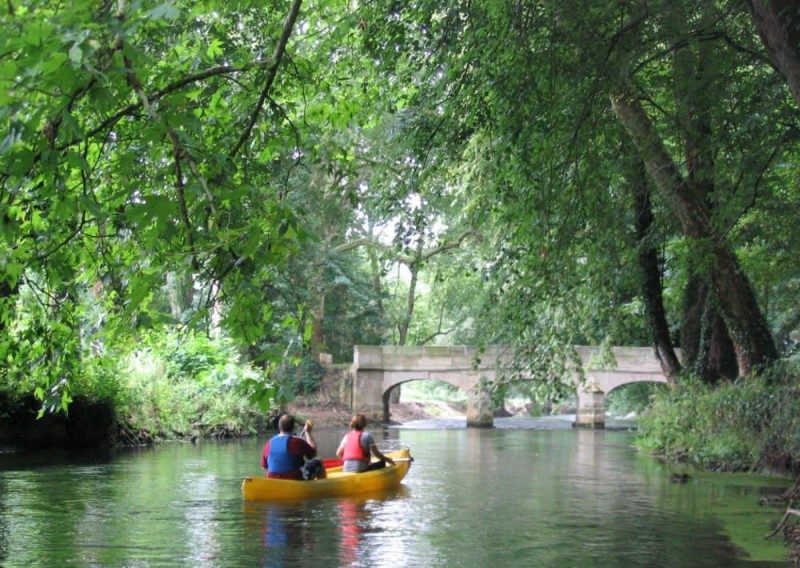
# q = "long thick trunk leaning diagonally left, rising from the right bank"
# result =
<box><xmin>610</xmin><ymin>81</ymin><xmax>777</xmax><ymax>375</ymax></box>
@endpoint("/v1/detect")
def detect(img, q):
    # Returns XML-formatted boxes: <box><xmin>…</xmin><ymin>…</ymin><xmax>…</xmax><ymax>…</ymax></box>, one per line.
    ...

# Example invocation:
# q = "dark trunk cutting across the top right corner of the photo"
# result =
<box><xmin>747</xmin><ymin>0</ymin><xmax>800</xmax><ymax>104</ymax></box>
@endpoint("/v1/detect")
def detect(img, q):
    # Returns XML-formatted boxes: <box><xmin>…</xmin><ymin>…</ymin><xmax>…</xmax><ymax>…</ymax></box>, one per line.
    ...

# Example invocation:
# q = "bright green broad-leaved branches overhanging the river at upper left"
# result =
<box><xmin>0</xmin><ymin>0</ymin><xmax>368</xmax><ymax>408</ymax></box>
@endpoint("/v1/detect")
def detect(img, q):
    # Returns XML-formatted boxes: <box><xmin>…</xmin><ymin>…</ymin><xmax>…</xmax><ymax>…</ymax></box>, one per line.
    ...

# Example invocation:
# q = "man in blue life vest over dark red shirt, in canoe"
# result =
<box><xmin>261</xmin><ymin>414</ymin><xmax>325</xmax><ymax>479</ymax></box>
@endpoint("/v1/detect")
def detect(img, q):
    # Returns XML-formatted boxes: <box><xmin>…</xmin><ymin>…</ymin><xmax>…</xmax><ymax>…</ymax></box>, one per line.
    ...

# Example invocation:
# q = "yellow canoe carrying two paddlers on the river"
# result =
<box><xmin>242</xmin><ymin>448</ymin><xmax>412</xmax><ymax>501</ymax></box>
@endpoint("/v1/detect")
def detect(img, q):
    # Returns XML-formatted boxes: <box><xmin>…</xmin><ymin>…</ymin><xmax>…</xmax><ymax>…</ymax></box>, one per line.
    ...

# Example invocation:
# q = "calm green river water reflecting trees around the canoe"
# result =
<box><xmin>0</xmin><ymin>418</ymin><xmax>788</xmax><ymax>568</ymax></box>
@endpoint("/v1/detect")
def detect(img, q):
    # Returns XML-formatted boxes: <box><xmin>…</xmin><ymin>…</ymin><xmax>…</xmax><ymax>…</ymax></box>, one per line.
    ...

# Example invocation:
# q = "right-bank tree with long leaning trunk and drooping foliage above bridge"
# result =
<box><xmin>362</xmin><ymin>1</ymin><xmax>786</xmax><ymax>382</ymax></box>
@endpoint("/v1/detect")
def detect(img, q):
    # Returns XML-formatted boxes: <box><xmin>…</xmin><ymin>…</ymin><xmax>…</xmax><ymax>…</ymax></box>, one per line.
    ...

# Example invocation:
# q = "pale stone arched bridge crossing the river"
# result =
<box><xmin>350</xmin><ymin>345</ymin><xmax>667</xmax><ymax>428</ymax></box>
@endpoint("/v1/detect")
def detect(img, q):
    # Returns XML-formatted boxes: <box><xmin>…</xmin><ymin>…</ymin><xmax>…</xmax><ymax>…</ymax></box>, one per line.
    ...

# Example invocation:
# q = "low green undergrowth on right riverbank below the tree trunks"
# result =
<box><xmin>637</xmin><ymin>368</ymin><xmax>800</xmax><ymax>471</ymax></box>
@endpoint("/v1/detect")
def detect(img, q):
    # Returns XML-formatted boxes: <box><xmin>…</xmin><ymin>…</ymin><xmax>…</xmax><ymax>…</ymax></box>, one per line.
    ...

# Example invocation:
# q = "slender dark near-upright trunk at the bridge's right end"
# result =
<box><xmin>628</xmin><ymin>155</ymin><xmax>681</xmax><ymax>384</ymax></box>
